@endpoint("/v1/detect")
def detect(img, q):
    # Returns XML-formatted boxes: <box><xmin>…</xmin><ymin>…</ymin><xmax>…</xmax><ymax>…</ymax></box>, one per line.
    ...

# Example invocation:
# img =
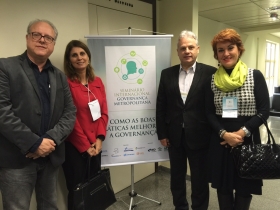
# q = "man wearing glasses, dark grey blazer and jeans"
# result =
<box><xmin>0</xmin><ymin>20</ymin><xmax>76</xmax><ymax>210</ymax></box>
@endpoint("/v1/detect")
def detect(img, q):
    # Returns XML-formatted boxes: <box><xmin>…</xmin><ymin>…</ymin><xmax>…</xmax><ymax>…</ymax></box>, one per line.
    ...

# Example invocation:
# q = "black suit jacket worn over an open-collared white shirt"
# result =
<box><xmin>156</xmin><ymin>63</ymin><xmax>216</xmax><ymax>149</ymax></box>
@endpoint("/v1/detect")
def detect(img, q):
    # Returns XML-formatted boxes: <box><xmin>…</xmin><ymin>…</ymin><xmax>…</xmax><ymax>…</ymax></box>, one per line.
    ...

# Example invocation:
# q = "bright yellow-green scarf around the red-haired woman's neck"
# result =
<box><xmin>214</xmin><ymin>60</ymin><xmax>248</xmax><ymax>92</ymax></box>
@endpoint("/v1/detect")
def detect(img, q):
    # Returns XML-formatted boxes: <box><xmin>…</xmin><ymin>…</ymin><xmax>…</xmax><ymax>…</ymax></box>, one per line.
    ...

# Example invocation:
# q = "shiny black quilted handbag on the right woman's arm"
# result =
<box><xmin>232</xmin><ymin>114</ymin><xmax>280</xmax><ymax>179</ymax></box>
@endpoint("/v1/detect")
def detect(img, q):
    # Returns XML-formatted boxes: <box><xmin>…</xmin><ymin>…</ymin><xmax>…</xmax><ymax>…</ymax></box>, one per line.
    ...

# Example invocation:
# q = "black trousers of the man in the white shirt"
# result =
<box><xmin>168</xmin><ymin>132</ymin><xmax>209</xmax><ymax>210</ymax></box>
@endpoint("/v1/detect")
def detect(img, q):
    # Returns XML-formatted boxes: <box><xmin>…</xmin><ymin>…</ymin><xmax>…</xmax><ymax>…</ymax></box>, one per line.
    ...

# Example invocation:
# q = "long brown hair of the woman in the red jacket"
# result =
<box><xmin>64</xmin><ymin>40</ymin><xmax>95</xmax><ymax>81</ymax></box>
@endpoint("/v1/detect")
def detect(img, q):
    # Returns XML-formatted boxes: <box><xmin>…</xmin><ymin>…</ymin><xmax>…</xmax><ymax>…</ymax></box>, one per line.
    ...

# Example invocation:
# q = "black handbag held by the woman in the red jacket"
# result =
<box><xmin>73</xmin><ymin>157</ymin><xmax>116</xmax><ymax>210</ymax></box>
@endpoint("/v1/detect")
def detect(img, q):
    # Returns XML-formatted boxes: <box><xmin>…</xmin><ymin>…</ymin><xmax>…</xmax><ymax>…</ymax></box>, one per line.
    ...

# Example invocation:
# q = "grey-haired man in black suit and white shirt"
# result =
<box><xmin>156</xmin><ymin>31</ymin><xmax>216</xmax><ymax>210</ymax></box>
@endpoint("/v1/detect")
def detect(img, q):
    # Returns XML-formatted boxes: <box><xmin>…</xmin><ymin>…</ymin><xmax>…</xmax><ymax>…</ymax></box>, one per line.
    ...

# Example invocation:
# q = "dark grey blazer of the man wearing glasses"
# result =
<box><xmin>0</xmin><ymin>52</ymin><xmax>76</xmax><ymax>168</ymax></box>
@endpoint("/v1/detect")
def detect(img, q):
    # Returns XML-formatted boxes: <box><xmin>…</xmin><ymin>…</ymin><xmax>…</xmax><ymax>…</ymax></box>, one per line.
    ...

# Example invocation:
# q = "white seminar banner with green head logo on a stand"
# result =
<box><xmin>85</xmin><ymin>35</ymin><xmax>173</xmax><ymax>167</ymax></box>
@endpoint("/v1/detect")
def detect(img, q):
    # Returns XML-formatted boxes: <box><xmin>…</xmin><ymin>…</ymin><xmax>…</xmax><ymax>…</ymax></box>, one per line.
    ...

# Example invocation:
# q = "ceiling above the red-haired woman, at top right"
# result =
<box><xmin>199</xmin><ymin>0</ymin><xmax>280</xmax><ymax>33</ymax></box>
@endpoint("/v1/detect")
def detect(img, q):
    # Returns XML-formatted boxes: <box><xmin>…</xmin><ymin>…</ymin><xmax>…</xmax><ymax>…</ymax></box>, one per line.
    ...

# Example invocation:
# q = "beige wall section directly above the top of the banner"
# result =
<box><xmin>89</xmin><ymin>0</ymin><xmax>153</xmax><ymax>35</ymax></box>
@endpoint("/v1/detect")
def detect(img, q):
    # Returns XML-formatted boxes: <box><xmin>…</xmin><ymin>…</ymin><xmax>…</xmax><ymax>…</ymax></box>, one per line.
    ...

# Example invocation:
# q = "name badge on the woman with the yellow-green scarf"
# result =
<box><xmin>222</xmin><ymin>97</ymin><xmax>238</xmax><ymax>118</ymax></box>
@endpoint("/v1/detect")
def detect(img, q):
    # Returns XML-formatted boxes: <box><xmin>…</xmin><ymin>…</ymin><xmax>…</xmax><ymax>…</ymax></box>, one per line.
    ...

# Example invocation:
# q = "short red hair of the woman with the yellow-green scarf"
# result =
<box><xmin>211</xmin><ymin>28</ymin><xmax>245</xmax><ymax>59</ymax></box>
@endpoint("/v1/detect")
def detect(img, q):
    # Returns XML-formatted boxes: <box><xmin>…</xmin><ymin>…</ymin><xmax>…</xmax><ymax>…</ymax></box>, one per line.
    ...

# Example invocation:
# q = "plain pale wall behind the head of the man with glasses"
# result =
<box><xmin>0</xmin><ymin>0</ymin><xmax>89</xmax><ymax>69</ymax></box>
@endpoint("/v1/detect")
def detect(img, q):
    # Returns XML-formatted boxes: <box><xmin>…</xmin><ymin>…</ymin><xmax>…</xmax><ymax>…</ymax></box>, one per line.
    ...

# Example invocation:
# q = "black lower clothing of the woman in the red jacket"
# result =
<box><xmin>62</xmin><ymin>142</ymin><xmax>101</xmax><ymax>210</ymax></box>
